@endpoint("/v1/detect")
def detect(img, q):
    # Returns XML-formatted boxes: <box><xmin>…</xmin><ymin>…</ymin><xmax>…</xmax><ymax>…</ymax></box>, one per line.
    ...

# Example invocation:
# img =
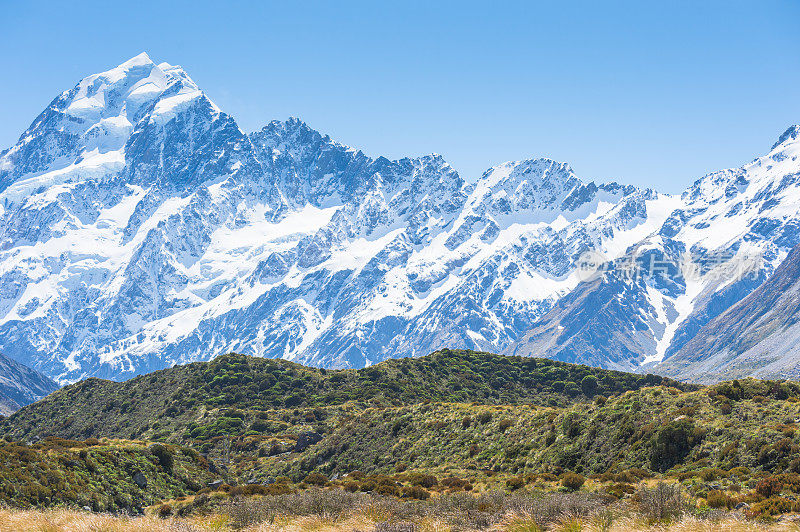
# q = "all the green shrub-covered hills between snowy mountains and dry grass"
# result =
<box><xmin>0</xmin><ymin>351</ymin><xmax>800</xmax><ymax>515</ymax></box>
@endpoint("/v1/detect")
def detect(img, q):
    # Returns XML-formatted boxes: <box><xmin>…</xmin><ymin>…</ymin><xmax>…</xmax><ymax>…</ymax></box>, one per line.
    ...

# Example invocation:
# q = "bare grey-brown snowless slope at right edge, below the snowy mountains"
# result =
<box><xmin>656</xmin><ymin>241</ymin><xmax>800</xmax><ymax>382</ymax></box>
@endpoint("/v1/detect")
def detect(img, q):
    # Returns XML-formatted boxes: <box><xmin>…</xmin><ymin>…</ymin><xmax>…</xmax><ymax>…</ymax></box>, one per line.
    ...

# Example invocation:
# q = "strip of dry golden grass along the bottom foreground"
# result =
<box><xmin>0</xmin><ymin>490</ymin><xmax>800</xmax><ymax>532</ymax></box>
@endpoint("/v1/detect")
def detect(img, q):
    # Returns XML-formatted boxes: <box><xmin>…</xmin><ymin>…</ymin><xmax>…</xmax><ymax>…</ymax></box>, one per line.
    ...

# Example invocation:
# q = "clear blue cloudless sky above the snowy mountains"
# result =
<box><xmin>0</xmin><ymin>0</ymin><xmax>800</xmax><ymax>192</ymax></box>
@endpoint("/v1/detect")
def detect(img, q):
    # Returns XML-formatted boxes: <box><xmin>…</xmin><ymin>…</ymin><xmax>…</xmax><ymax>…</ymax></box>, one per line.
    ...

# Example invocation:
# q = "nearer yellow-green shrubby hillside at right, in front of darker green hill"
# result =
<box><xmin>212</xmin><ymin>380</ymin><xmax>800</xmax><ymax>479</ymax></box>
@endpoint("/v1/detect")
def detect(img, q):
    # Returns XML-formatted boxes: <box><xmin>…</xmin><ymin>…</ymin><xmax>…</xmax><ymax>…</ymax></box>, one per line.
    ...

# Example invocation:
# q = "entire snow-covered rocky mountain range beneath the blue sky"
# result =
<box><xmin>0</xmin><ymin>54</ymin><xmax>800</xmax><ymax>383</ymax></box>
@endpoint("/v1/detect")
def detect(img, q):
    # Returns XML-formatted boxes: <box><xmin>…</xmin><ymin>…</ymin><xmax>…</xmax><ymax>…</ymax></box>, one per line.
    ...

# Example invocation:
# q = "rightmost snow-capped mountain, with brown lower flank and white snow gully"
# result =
<box><xmin>506</xmin><ymin>126</ymin><xmax>800</xmax><ymax>378</ymax></box>
